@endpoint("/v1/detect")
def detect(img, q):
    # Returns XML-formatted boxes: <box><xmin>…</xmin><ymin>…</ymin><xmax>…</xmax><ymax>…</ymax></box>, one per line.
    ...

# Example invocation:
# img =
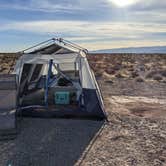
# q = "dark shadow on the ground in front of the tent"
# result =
<box><xmin>0</xmin><ymin>118</ymin><xmax>104</xmax><ymax>166</ymax></box>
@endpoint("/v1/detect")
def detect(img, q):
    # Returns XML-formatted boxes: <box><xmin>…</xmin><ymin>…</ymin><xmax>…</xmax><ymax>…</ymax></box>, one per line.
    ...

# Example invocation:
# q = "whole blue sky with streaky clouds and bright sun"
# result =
<box><xmin>0</xmin><ymin>0</ymin><xmax>166</xmax><ymax>52</ymax></box>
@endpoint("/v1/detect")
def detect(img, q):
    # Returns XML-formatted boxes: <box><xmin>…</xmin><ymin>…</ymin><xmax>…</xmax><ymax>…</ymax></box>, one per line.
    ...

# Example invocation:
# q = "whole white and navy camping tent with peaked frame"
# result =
<box><xmin>14</xmin><ymin>38</ymin><xmax>106</xmax><ymax>119</ymax></box>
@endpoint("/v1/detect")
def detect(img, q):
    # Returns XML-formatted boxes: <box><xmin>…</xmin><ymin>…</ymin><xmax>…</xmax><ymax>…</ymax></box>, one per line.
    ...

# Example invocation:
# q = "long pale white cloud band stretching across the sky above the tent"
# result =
<box><xmin>0</xmin><ymin>20</ymin><xmax>166</xmax><ymax>39</ymax></box>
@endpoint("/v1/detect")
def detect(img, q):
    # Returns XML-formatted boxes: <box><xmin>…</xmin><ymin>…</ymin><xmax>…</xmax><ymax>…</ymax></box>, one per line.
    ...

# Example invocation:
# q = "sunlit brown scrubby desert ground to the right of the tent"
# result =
<box><xmin>82</xmin><ymin>55</ymin><xmax>166</xmax><ymax>166</ymax></box>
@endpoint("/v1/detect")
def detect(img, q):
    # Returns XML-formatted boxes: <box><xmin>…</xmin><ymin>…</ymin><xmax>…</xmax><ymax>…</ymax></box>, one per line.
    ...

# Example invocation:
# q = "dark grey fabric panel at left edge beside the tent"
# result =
<box><xmin>0</xmin><ymin>74</ymin><xmax>17</xmax><ymax>139</ymax></box>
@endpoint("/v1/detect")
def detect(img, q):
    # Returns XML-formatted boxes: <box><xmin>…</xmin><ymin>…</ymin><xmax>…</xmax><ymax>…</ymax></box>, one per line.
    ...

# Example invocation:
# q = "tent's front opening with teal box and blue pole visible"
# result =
<box><xmin>19</xmin><ymin>59</ymin><xmax>82</xmax><ymax>110</ymax></box>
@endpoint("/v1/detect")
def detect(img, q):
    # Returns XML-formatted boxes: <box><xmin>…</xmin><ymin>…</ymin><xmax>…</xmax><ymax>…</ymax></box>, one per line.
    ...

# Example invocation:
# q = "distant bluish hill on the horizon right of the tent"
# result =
<box><xmin>91</xmin><ymin>46</ymin><xmax>166</xmax><ymax>54</ymax></box>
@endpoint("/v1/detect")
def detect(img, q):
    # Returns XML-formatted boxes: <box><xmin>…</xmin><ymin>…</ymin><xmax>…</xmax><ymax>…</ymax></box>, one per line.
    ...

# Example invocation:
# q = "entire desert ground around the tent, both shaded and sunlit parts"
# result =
<box><xmin>0</xmin><ymin>54</ymin><xmax>166</xmax><ymax>166</ymax></box>
